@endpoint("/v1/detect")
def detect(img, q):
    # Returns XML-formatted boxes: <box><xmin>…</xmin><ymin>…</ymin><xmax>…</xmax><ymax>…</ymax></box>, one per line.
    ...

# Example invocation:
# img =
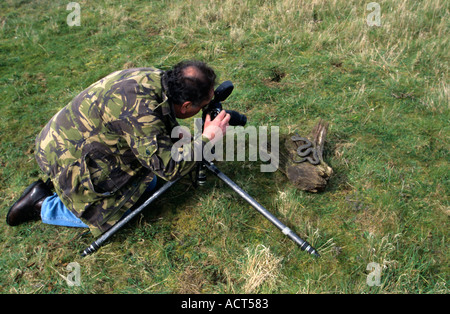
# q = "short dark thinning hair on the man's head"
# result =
<box><xmin>163</xmin><ymin>61</ymin><xmax>216</xmax><ymax>106</ymax></box>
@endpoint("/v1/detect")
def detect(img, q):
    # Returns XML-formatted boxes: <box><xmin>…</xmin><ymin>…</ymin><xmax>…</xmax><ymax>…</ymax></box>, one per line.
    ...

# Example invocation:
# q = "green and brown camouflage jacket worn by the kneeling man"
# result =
<box><xmin>36</xmin><ymin>68</ymin><xmax>204</xmax><ymax>236</ymax></box>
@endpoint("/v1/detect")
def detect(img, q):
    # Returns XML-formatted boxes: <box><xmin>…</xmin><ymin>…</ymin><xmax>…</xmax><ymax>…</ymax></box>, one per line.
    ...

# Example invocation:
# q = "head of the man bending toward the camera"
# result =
<box><xmin>164</xmin><ymin>61</ymin><xmax>216</xmax><ymax>119</ymax></box>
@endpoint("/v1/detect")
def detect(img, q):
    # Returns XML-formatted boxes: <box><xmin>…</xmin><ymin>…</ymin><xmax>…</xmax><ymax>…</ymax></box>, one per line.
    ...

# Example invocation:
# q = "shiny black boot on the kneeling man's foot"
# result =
<box><xmin>6</xmin><ymin>179</ymin><xmax>53</xmax><ymax>226</ymax></box>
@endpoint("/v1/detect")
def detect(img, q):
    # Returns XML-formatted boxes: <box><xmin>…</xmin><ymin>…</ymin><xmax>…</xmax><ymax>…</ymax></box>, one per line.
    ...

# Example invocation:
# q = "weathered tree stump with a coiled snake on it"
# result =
<box><xmin>279</xmin><ymin>119</ymin><xmax>333</xmax><ymax>193</ymax></box>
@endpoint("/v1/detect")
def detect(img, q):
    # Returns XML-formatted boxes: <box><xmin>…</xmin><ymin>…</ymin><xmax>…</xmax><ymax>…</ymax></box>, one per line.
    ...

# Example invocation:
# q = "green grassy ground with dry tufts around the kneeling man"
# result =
<box><xmin>0</xmin><ymin>0</ymin><xmax>450</xmax><ymax>293</ymax></box>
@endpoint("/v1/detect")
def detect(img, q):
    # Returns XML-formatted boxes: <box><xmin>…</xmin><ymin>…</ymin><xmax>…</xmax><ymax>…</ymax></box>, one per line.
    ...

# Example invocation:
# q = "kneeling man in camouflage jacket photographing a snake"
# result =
<box><xmin>6</xmin><ymin>61</ymin><xmax>230</xmax><ymax>236</ymax></box>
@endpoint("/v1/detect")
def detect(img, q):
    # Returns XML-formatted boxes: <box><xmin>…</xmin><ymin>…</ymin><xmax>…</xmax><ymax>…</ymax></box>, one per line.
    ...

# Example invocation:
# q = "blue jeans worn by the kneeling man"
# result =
<box><xmin>41</xmin><ymin>176</ymin><xmax>156</xmax><ymax>228</ymax></box>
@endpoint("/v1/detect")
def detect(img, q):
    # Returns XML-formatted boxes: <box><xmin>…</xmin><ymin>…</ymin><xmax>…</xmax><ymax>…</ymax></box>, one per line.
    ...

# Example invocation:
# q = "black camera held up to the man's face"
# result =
<box><xmin>202</xmin><ymin>81</ymin><xmax>247</xmax><ymax>126</ymax></box>
